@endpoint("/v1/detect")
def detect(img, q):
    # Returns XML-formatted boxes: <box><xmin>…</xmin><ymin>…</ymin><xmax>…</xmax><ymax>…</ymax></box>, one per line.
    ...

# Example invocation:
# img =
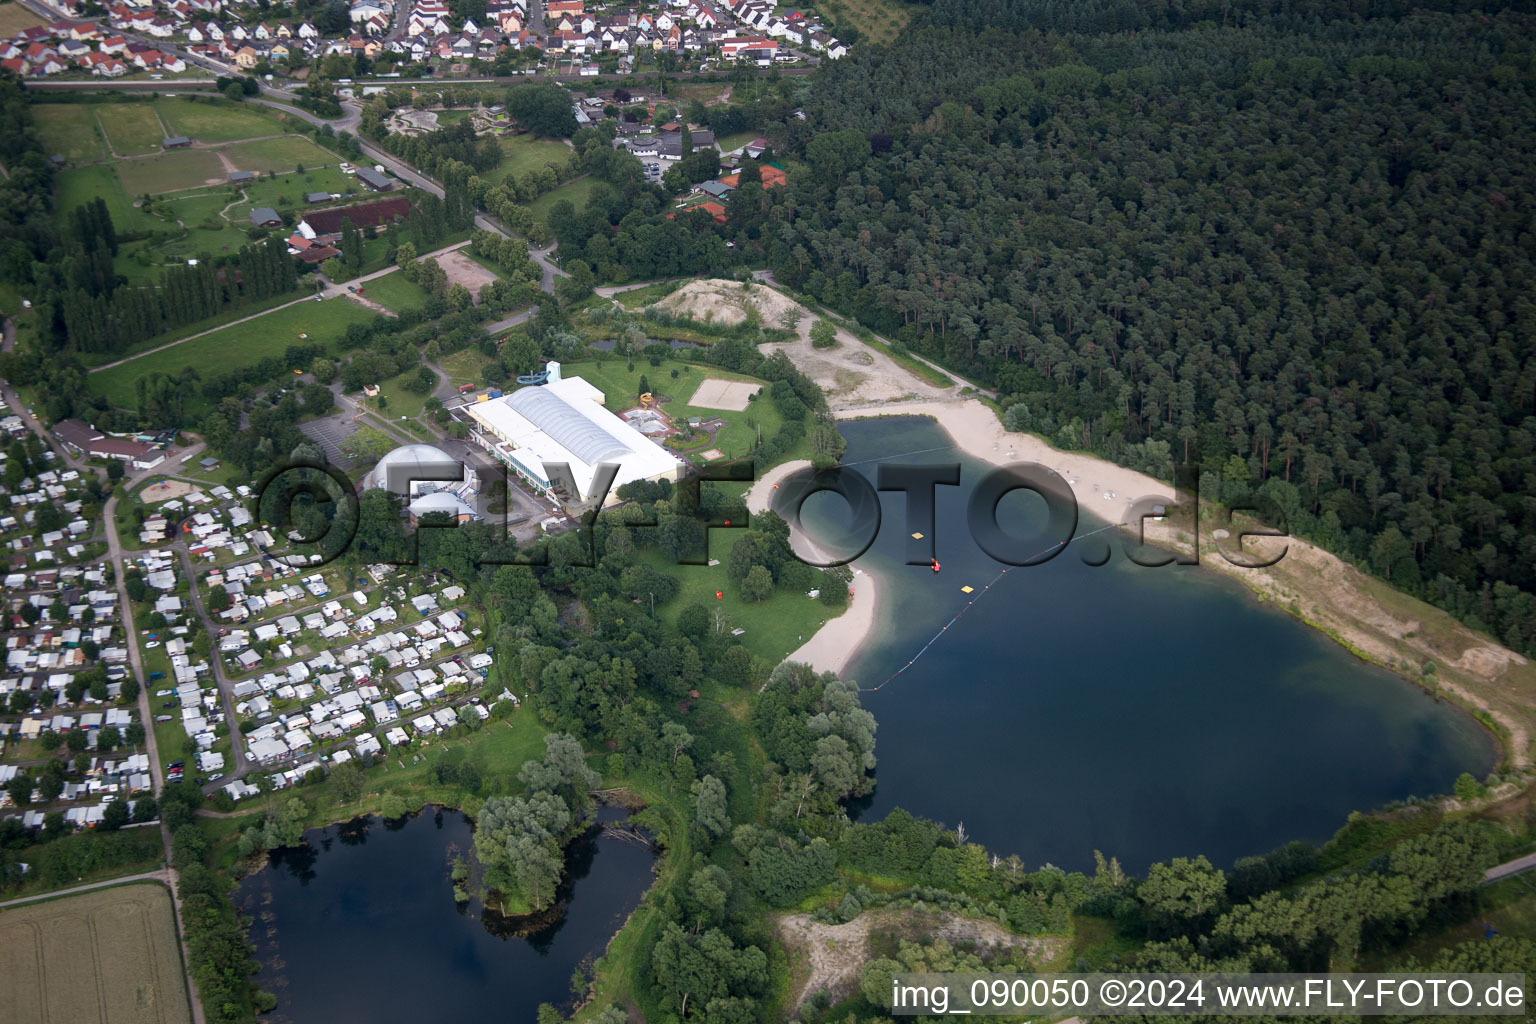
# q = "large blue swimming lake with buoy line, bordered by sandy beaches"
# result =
<box><xmin>805</xmin><ymin>418</ymin><xmax>1496</xmax><ymax>872</ymax></box>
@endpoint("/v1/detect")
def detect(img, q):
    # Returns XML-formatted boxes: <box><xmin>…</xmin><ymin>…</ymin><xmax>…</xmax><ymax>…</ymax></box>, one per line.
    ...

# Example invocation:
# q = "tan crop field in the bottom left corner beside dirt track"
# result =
<box><xmin>0</xmin><ymin>883</ymin><xmax>192</xmax><ymax>1024</ymax></box>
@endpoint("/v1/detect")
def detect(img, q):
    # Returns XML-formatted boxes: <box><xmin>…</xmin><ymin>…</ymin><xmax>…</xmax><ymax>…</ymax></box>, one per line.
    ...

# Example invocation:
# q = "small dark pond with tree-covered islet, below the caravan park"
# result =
<box><xmin>237</xmin><ymin>808</ymin><xmax>654</xmax><ymax>1024</ymax></box>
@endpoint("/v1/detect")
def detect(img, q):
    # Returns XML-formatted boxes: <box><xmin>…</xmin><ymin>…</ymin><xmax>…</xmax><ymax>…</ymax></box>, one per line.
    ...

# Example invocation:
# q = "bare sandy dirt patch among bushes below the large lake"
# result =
<box><xmin>776</xmin><ymin>909</ymin><xmax>1069</xmax><ymax>1009</ymax></box>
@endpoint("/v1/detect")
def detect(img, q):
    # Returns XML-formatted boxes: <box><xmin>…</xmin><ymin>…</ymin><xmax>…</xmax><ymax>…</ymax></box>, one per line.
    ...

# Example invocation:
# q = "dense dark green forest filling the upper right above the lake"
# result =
<box><xmin>550</xmin><ymin>2</ymin><xmax>1536</xmax><ymax>654</ymax></box>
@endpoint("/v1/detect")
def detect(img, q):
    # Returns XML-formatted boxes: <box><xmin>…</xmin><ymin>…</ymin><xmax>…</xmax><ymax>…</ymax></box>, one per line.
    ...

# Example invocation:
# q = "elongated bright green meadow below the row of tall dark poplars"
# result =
<box><xmin>86</xmin><ymin>298</ymin><xmax>378</xmax><ymax>408</ymax></box>
